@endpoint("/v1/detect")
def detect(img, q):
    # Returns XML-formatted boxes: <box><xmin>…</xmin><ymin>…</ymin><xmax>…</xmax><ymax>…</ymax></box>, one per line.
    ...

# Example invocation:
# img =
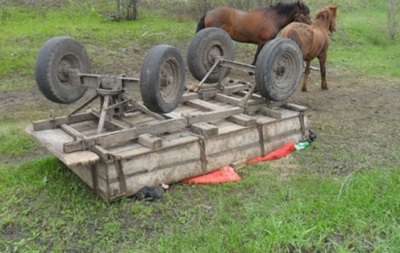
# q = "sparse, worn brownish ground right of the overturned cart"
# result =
<box><xmin>292</xmin><ymin>67</ymin><xmax>400</xmax><ymax>173</ymax></box>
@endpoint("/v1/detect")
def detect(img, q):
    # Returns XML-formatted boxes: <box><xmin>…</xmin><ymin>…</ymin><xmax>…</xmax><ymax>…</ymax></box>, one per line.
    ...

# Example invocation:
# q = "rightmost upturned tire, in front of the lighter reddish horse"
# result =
<box><xmin>255</xmin><ymin>38</ymin><xmax>303</xmax><ymax>101</ymax></box>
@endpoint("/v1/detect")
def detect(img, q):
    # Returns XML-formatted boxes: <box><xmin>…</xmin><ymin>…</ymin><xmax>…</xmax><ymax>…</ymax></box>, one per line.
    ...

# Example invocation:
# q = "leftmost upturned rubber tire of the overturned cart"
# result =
<box><xmin>35</xmin><ymin>36</ymin><xmax>91</xmax><ymax>104</ymax></box>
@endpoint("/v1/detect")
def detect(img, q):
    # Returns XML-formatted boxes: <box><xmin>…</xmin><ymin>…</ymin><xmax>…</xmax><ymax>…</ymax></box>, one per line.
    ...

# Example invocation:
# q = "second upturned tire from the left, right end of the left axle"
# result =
<box><xmin>140</xmin><ymin>44</ymin><xmax>185</xmax><ymax>113</ymax></box>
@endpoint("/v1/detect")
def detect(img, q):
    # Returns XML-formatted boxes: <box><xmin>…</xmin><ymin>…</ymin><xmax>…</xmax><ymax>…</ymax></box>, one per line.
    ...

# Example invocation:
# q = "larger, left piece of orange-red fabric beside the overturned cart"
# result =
<box><xmin>183</xmin><ymin>166</ymin><xmax>241</xmax><ymax>184</ymax></box>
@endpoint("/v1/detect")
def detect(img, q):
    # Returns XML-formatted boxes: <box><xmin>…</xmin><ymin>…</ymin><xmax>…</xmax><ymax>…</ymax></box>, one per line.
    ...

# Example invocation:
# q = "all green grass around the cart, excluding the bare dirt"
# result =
<box><xmin>0</xmin><ymin>1</ymin><xmax>400</xmax><ymax>252</ymax></box>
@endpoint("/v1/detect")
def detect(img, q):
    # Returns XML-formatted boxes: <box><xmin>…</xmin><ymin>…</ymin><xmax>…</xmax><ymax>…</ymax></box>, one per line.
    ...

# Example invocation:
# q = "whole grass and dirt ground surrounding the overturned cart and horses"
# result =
<box><xmin>0</xmin><ymin>0</ymin><xmax>400</xmax><ymax>252</ymax></box>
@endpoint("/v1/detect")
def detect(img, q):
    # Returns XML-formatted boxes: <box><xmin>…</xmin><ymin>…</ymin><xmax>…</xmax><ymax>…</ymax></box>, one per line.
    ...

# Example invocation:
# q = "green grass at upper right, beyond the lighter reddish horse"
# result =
<box><xmin>328</xmin><ymin>9</ymin><xmax>400</xmax><ymax>77</ymax></box>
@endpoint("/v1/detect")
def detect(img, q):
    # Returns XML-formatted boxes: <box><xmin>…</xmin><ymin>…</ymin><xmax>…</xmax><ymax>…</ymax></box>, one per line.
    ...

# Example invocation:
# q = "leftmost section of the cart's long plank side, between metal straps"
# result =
<box><xmin>107</xmin><ymin>142</ymin><xmax>206</xmax><ymax>199</ymax></box>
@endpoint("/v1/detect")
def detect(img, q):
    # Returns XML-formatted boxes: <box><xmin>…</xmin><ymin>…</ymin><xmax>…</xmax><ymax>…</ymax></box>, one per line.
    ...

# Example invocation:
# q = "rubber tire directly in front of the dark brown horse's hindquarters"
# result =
<box><xmin>187</xmin><ymin>28</ymin><xmax>235</xmax><ymax>83</ymax></box>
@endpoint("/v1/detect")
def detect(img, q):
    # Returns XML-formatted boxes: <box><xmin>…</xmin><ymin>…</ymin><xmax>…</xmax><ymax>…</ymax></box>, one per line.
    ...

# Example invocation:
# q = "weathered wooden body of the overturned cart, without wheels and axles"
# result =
<box><xmin>27</xmin><ymin>85</ymin><xmax>307</xmax><ymax>201</ymax></box>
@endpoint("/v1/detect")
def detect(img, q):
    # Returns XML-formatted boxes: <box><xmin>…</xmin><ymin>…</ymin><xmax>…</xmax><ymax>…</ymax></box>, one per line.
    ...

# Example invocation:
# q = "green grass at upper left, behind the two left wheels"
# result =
<box><xmin>0</xmin><ymin>4</ymin><xmax>194</xmax><ymax>91</ymax></box>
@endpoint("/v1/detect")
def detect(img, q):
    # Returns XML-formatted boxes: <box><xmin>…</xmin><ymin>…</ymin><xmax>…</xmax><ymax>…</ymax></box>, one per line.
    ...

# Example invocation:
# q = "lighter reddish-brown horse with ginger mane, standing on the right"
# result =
<box><xmin>280</xmin><ymin>6</ymin><xmax>337</xmax><ymax>91</ymax></box>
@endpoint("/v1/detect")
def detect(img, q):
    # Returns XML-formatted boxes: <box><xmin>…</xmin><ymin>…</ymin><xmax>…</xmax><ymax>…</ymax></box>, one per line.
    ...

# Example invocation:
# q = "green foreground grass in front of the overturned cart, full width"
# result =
<box><xmin>0</xmin><ymin>157</ymin><xmax>400</xmax><ymax>252</ymax></box>
